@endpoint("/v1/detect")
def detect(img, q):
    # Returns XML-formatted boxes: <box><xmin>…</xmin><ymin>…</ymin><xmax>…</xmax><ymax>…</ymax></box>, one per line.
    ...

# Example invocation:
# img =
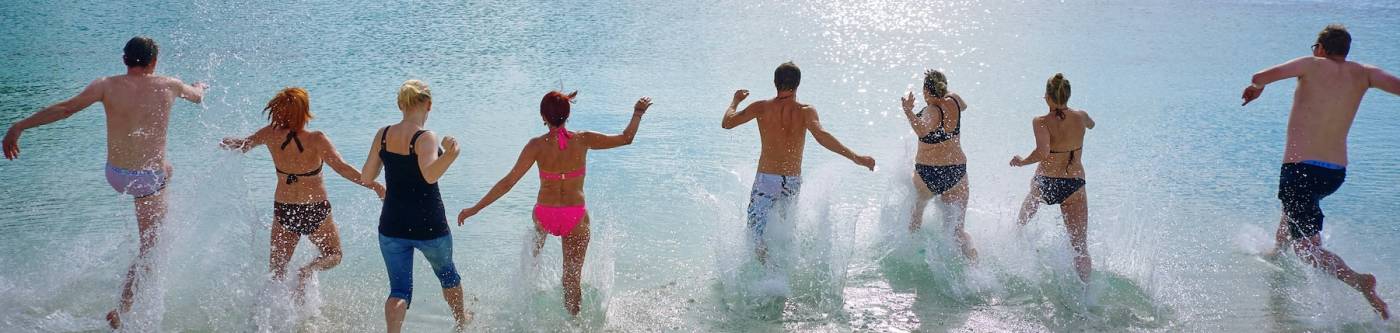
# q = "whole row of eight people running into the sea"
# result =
<box><xmin>3</xmin><ymin>25</ymin><xmax>1400</xmax><ymax>332</ymax></box>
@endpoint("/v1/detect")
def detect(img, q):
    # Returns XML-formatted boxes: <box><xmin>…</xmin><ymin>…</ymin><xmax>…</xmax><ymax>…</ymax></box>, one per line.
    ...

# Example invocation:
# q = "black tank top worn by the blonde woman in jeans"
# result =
<box><xmin>379</xmin><ymin>127</ymin><xmax>451</xmax><ymax>241</ymax></box>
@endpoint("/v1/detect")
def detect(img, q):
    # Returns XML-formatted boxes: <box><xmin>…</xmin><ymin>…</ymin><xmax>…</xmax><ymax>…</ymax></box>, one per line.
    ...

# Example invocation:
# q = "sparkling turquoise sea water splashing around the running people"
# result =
<box><xmin>0</xmin><ymin>1</ymin><xmax>1400</xmax><ymax>332</ymax></box>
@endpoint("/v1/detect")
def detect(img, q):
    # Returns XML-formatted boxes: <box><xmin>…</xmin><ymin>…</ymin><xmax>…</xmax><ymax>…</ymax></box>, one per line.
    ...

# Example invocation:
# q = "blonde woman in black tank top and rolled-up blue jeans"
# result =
<box><xmin>363</xmin><ymin>80</ymin><xmax>470</xmax><ymax>332</ymax></box>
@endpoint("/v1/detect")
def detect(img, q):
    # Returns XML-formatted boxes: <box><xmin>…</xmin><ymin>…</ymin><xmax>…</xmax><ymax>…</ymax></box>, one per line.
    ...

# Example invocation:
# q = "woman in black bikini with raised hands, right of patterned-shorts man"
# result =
<box><xmin>902</xmin><ymin>70</ymin><xmax>977</xmax><ymax>262</ymax></box>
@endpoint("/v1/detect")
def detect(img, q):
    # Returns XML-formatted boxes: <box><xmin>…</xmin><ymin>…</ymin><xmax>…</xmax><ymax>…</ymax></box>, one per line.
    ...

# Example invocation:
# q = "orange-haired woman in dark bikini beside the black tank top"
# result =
<box><xmin>223</xmin><ymin>88</ymin><xmax>384</xmax><ymax>292</ymax></box>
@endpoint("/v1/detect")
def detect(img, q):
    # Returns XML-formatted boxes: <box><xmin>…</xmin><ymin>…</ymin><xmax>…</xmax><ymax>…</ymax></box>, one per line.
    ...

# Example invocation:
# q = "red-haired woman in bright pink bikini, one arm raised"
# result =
<box><xmin>456</xmin><ymin>91</ymin><xmax>651</xmax><ymax>315</ymax></box>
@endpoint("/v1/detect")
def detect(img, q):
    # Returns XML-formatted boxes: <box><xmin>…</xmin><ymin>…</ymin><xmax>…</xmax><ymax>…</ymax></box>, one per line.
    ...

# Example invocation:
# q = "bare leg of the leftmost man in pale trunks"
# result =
<box><xmin>106</xmin><ymin>193</ymin><xmax>167</xmax><ymax>329</ymax></box>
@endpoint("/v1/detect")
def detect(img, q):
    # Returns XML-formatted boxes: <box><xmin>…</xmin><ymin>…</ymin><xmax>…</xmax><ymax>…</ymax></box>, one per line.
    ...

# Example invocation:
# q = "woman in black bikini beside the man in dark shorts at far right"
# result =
<box><xmin>1011</xmin><ymin>73</ymin><xmax>1093</xmax><ymax>281</ymax></box>
